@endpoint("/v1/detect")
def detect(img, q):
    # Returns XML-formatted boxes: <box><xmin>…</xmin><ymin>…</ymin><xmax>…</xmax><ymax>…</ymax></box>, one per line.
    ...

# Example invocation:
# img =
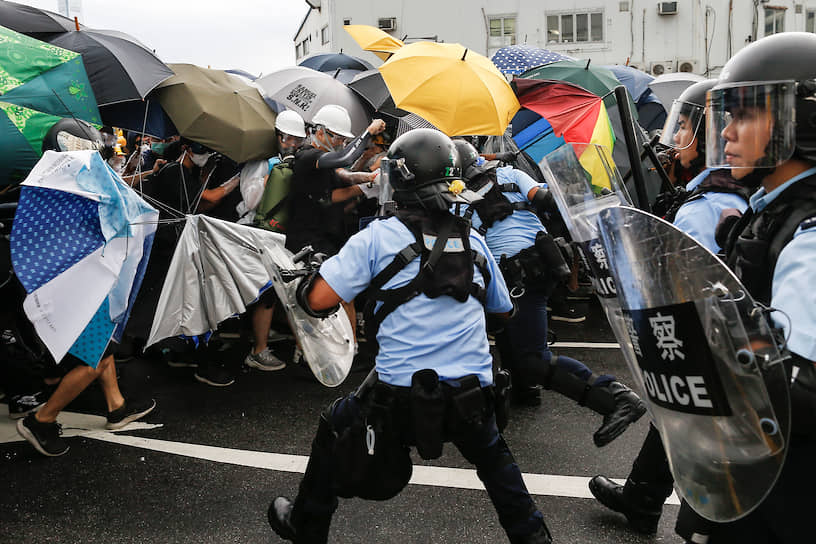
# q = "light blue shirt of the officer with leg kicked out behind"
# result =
<box><xmin>463</xmin><ymin>166</ymin><xmax>547</xmax><ymax>262</ymax></box>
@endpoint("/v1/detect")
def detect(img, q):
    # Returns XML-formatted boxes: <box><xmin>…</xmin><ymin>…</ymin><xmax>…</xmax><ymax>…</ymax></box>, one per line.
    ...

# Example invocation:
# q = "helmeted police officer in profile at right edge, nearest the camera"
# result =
<box><xmin>678</xmin><ymin>32</ymin><xmax>816</xmax><ymax>544</ymax></box>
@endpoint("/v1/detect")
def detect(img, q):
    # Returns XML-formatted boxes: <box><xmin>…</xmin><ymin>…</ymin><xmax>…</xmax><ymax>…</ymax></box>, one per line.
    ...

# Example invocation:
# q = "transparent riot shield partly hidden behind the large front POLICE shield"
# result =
<box><xmin>539</xmin><ymin>143</ymin><xmax>646</xmax><ymax>396</ymax></box>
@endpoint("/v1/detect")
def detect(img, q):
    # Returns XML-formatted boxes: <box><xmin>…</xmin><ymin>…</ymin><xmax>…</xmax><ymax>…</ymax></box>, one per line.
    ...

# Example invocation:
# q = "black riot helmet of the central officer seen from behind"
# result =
<box><xmin>387</xmin><ymin>128</ymin><xmax>482</xmax><ymax>211</ymax></box>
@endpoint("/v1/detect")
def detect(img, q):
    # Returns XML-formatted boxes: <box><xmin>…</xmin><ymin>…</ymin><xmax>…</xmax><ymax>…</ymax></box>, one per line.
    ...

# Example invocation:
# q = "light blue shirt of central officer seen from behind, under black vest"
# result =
<box><xmin>320</xmin><ymin>217</ymin><xmax>513</xmax><ymax>387</ymax></box>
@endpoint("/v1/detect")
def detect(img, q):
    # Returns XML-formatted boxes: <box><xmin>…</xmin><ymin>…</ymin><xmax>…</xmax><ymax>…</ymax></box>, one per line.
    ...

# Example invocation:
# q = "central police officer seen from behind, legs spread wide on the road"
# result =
<box><xmin>268</xmin><ymin>129</ymin><xmax>551</xmax><ymax>543</ymax></box>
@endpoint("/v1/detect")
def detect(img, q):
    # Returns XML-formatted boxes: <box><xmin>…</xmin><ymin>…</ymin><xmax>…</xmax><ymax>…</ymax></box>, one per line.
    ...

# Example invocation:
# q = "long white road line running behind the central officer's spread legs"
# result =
<box><xmin>85</xmin><ymin>432</ymin><xmax>680</xmax><ymax>505</ymax></box>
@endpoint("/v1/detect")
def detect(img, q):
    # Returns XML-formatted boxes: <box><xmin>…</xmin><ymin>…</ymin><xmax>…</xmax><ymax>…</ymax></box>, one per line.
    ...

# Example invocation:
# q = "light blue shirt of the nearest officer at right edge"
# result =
<box><xmin>751</xmin><ymin>168</ymin><xmax>816</xmax><ymax>361</ymax></box>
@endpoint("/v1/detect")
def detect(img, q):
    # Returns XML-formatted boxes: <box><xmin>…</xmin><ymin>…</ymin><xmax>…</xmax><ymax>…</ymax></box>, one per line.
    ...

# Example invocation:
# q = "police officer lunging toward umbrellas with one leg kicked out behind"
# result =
<box><xmin>454</xmin><ymin>140</ymin><xmax>646</xmax><ymax>447</ymax></box>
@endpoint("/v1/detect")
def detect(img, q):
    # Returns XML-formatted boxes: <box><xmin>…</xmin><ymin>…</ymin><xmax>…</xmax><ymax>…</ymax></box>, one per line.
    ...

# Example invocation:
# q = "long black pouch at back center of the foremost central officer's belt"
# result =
<box><xmin>410</xmin><ymin>368</ymin><xmax>445</xmax><ymax>460</ymax></box>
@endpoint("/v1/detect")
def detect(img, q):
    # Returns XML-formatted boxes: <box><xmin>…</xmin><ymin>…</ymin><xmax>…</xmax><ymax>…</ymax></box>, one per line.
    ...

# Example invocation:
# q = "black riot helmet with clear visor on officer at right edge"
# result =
<box><xmin>706</xmin><ymin>32</ymin><xmax>816</xmax><ymax>168</ymax></box>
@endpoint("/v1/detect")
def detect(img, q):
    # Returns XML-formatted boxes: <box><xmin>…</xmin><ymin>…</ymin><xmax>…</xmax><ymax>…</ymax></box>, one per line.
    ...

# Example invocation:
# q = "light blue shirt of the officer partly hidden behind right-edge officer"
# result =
<box><xmin>674</xmin><ymin>169</ymin><xmax>748</xmax><ymax>253</ymax></box>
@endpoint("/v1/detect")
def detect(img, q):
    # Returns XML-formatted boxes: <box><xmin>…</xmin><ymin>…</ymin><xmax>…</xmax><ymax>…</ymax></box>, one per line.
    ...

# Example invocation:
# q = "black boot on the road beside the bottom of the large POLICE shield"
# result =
<box><xmin>589</xmin><ymin>475</ymin><xmax>669</xmax><ymax>534</ymax></box>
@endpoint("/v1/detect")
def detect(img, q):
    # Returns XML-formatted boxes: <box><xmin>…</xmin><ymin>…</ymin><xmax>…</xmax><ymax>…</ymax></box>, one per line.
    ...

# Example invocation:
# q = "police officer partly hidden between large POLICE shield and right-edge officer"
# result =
<box><xmin>589</xmin><ymin>79</ymin><xmax>758</xmax><ymax>534</ymax></box>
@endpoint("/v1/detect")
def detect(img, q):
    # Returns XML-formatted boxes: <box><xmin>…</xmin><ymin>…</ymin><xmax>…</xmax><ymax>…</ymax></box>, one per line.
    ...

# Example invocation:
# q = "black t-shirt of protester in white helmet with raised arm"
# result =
<box><xmin>286</xmin><ymin>147</ymin><xmax>345</xmax><ymax>255</ymax></box>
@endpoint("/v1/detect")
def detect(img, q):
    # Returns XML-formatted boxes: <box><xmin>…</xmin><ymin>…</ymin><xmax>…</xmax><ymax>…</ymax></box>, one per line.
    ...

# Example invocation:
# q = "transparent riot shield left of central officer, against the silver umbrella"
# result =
<box><xmin>266</xmin><ymin>244</ymin><xmax>354</xmax><ymax>387</ymax></box>
